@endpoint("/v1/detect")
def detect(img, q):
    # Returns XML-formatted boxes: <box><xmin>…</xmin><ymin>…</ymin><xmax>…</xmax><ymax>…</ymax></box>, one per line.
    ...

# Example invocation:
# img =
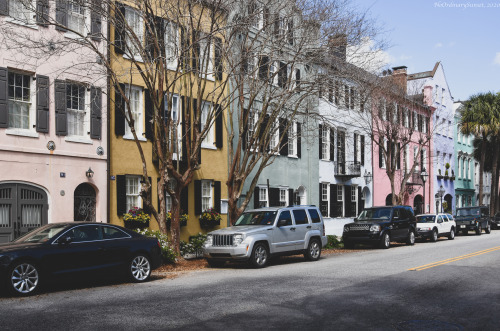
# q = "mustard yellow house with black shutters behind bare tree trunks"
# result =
<box><xmin>108</xmin><ymin>2</ymin><xmax>228</xmax><ymax>241</ymax></box>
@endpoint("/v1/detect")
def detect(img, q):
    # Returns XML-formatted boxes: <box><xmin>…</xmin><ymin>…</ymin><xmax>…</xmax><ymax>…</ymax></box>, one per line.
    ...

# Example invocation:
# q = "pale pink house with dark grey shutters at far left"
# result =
<box><xmin>0</xmin><ymin>0</ymin><xmax>108</xmax><ymax>243</ymax></box>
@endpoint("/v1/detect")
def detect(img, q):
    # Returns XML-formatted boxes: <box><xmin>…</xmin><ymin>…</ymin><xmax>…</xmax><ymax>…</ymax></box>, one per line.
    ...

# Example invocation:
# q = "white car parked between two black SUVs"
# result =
<box><xmin>417</xmin><ymin>213</ymin><xmax>457</xmax><ymax>241</ymax></box>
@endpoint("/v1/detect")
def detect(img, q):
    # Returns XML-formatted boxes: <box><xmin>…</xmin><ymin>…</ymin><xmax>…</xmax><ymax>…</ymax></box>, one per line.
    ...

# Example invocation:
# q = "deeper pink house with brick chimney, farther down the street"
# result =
<box><xmin>372</xmin><ymin>67</ymin><xmax>434</xmax><ymax>214</ymax></box>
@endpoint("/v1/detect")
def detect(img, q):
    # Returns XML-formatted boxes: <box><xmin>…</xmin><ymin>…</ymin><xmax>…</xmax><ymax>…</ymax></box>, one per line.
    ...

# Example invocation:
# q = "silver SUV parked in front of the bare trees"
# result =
<box><xmin>203</xmin><ymin>206</ymin><xmax>327</xmax><ymax>268</ymax></box>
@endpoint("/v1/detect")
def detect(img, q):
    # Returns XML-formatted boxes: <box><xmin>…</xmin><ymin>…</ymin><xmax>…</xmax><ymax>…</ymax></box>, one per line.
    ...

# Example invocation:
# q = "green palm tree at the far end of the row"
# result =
<box><xmin>459</xmin><ymin>92</ymin><xmax>500</xmax><ymax>213</ymax></box>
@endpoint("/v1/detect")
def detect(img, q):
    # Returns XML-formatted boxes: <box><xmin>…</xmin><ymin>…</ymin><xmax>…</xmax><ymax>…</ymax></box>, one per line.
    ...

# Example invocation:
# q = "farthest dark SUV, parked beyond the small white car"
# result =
<box><xmin>455</xmin><ymin>206</ymin><xmax>491</xmax><ymax>235</ymax></box>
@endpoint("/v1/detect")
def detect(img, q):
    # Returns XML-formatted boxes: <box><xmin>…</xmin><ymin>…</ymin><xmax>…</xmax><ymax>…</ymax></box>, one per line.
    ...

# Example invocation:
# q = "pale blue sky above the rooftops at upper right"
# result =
<box><xmin>353</xmin><ymin>0</ymin><xmax>500</xmax><ymax>101</ymax></box>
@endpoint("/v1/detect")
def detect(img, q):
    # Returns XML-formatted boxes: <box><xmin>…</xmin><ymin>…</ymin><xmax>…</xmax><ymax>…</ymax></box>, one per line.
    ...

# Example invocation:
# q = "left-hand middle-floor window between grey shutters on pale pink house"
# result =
<box><xmin>8</xmin><ymin>72</ymin><xmax>31</xmax><ymax>129</ymax></box>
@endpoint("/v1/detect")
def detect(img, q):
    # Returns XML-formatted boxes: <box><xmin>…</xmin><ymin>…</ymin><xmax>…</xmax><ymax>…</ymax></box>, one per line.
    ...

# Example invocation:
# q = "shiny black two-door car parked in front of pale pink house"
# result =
<box><xmin>0</xmin><ymin>222</ymin><xmax>161</xmax><ymax>295</ymax></box>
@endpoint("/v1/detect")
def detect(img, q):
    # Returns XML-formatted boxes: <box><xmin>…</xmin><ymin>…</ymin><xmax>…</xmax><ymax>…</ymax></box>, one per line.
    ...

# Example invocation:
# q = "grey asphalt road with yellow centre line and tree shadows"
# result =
<box><xmin>0</xmin><ymin>231</ymin><xmax>500</xmax><ymax>330</ymax></box>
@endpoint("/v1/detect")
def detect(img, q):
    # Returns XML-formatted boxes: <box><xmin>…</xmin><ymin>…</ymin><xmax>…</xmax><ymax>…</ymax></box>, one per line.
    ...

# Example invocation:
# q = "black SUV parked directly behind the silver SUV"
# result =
<box><xmin>342</xmin><ymin>206</ymin><xmax>417</xmax><ymax>248</ymax></box>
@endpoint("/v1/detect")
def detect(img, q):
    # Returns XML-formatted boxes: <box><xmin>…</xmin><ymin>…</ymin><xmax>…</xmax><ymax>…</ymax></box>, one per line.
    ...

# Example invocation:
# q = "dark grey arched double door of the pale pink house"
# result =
<box><xmin>0</xmin><ymin>183</ymin><xmax>48</xmax><ymax>243</ymax></box>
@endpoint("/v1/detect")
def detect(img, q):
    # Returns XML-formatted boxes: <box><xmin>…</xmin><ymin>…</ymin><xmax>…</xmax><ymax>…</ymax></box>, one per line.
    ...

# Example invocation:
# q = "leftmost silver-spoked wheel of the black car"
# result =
<box><xmin>8</xmin><ymin>262</ymin><xmax>40</xmax><ymax>295</ymax></box>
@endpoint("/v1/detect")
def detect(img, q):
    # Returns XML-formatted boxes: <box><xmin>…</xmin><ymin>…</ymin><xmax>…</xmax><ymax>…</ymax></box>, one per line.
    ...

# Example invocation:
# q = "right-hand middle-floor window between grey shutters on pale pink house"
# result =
<box><xmin>66</xmin><ymin>83</ymin><xmax>87</xmax><ymax>136</ymax></box>
